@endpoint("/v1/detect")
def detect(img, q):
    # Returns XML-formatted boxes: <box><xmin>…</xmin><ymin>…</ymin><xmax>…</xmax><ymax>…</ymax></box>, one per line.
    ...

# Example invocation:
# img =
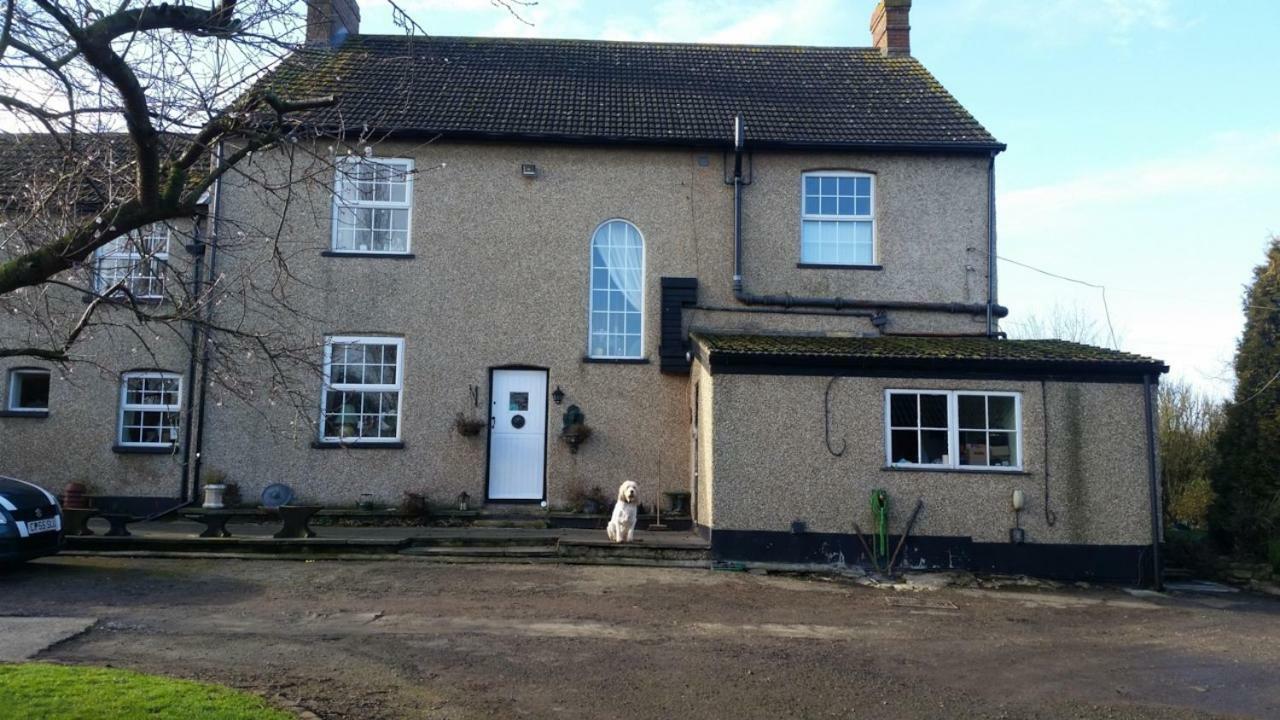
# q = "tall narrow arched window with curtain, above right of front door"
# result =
<box><xmin>588</xmin><ymin>215</ymin><xmax>644</xmax><ymax>359</ymax></box>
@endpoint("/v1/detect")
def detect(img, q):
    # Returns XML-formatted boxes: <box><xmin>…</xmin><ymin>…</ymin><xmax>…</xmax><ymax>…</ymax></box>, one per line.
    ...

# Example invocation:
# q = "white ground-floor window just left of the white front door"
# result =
<box><xmin>320</xmin><ymin>337</ymin><xmax>404</xmax><ymax>443</ymax></box>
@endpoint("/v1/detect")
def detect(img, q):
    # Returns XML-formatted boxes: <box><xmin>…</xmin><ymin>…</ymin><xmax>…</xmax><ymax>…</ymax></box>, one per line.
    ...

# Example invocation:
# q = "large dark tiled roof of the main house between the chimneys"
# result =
<box><xmin>262</xmin><ymin>35</ymin><xmax>1005</xmax><ymax>152</ymax></box>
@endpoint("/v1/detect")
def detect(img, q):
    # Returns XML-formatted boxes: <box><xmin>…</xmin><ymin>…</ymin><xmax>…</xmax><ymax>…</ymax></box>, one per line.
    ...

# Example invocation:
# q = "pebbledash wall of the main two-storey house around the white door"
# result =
<box><xmin>189</xmin><ymin>142</ymin><xmax>987</xmax><ymax>511</ymax></box>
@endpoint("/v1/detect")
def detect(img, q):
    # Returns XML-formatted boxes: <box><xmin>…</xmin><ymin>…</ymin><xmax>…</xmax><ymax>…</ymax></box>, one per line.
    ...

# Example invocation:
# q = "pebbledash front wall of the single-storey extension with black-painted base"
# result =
<box><xmin>695</xmin><ymin>364</ymin><xmax>1167</xmax><ymax>582</ymax></box>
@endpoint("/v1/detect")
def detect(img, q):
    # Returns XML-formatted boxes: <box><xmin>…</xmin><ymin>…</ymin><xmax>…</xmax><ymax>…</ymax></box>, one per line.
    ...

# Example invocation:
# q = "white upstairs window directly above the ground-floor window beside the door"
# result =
<box><xmin>333</xmin><ymin>158</ymin><xmax>413</xmax><ymax>255</ymax></box>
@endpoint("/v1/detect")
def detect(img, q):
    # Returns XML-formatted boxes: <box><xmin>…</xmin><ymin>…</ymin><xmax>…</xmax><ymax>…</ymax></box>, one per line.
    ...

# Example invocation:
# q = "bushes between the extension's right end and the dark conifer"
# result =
<box><xmin>1157</xmin><ymin>380</ymin><xmax>1222</xmax><ymax>528</ymax></box>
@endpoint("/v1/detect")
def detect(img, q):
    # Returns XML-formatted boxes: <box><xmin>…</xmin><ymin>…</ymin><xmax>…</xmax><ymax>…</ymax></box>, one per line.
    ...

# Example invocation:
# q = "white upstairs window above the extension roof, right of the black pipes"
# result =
<box><xmin>800</xmin><ymin>170</ymin><xmax>876</xmax><ymax>265</ymax></box>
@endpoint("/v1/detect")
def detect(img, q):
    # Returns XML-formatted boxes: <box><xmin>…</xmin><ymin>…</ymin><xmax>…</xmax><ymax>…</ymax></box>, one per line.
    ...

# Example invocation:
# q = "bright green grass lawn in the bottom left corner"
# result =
<box><xmin>0</xmin><ymin>662</ymin><xmax>293</xmax><ymax>720</ymax></box>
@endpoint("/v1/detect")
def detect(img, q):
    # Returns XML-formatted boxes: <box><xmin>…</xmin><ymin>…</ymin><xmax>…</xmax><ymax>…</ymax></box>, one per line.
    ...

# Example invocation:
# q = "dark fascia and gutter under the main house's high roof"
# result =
<box><xmin>290</xmin><ymin>126</ymin><xmax>1009</xmax><ymax>156</ymax></box>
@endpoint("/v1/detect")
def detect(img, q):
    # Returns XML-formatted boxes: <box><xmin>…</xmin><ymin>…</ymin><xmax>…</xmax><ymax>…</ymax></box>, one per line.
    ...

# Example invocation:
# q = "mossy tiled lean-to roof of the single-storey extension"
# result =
<box><xmin>692</xmin><ymin>332</ymin><xmax>1169</xmax><ymax>378</ymax></box>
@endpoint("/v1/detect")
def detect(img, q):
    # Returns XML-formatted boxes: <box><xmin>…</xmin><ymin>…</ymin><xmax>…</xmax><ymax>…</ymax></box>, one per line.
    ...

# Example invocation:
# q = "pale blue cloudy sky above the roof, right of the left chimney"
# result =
<box><xmin>361</xmin><ymin>0</ymin><xmax>1280</xmax><ymax>395</ymax></box>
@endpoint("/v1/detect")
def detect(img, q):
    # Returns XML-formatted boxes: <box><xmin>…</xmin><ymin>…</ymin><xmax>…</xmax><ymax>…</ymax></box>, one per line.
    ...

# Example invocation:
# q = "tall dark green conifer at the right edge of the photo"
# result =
<box><xmin>1210</xmin><ymin>237</ymin><xmax>1280</xmax><ymax>557</ymax></box>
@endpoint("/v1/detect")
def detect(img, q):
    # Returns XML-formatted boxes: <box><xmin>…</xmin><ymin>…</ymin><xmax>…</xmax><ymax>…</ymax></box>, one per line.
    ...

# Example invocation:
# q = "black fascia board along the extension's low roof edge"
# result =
<box><xmin>699</xmin><ymin>343</ymin><xmax>1169</xmax><ymax>383</ymax></box>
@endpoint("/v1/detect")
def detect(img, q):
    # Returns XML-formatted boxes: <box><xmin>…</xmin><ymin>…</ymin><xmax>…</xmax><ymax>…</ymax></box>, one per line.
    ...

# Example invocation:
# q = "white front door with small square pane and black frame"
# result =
<box><xmin>489</xmin><ymin>370</ymin><xmax>547</xmax><ymax>501</ymax></box>
